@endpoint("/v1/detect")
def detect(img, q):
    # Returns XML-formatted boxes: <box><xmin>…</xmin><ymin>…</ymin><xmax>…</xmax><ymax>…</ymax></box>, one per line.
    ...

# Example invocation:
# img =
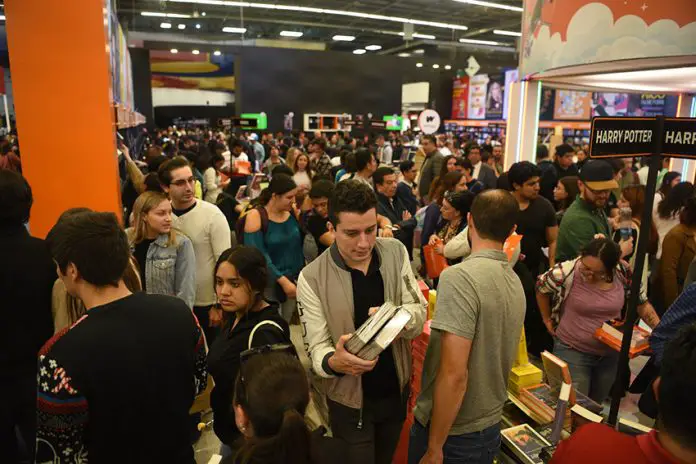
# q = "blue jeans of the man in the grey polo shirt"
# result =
<box><xmin>408</xmin><ymin>420</ymin><xmax>500</xmax><ymax>464</ymax></box>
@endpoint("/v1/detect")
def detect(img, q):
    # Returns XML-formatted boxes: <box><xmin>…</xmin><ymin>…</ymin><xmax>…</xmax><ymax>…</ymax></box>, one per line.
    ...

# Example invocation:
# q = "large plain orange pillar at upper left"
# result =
<box><xmin>5</xmin><ymin>0</ymin><xmax>122</xmax><ymax>237</ymax></box>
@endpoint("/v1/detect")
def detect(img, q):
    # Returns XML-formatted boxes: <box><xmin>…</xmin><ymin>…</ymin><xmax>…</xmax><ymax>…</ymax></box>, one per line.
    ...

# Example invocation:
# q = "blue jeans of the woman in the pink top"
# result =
<box><xmin>553</xmin><ymin>338</ymin><xmax>619</xmax><ymax>404</ymax></box>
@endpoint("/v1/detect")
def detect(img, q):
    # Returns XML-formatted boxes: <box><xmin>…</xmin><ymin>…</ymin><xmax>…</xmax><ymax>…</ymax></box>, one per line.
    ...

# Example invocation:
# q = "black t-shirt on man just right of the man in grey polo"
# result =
<box><xmin>517</xmin><ymin>196</ymin><xmax>556</xmax><ymax>276</ymax></box>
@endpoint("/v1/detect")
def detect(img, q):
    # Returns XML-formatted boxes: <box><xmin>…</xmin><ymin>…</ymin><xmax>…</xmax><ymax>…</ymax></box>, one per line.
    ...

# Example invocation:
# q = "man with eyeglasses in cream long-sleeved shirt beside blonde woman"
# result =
<box><xmin>157</xmin><ymin>157</ymin><xmax>231</xmax><ymax>345</ymax></box>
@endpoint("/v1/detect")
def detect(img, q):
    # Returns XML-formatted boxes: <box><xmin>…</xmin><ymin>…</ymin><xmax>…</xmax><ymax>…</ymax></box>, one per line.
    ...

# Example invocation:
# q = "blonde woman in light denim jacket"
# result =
<box><xmin>126</xmin><ymin>192</ymin><xmax>196</xmax><ymax>307</ymax></box>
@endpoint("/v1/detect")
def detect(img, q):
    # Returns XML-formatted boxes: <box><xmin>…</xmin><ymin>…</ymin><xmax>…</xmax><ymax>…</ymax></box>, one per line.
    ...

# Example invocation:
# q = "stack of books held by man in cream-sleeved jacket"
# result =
<box><xmin>345</xmin><ymin>303</ymin><xmax>411</xmax><ymax>361</ymax></box>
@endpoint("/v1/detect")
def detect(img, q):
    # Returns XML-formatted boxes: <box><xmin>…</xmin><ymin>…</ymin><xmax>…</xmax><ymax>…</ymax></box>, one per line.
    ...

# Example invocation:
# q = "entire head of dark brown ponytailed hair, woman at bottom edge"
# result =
<box><xmin>234</xmin><ymin>352</ymin><xmax>313</xmax><ymax>464</ymax></box>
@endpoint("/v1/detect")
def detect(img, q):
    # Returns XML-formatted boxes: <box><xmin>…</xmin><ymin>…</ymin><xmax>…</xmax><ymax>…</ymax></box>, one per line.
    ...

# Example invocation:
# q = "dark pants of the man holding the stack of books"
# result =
<box><xmin>328</xmin><ymin>389</ymin><xmax>409</xmax><ymax>464</ymax></box>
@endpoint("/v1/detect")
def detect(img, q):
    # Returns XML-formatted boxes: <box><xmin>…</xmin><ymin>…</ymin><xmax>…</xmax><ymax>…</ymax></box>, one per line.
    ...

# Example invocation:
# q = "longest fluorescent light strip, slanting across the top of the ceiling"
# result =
<box><xmin>164</xmin><ymin>0</ymin><xmax>468</xmax><ymax>31</ymax></box>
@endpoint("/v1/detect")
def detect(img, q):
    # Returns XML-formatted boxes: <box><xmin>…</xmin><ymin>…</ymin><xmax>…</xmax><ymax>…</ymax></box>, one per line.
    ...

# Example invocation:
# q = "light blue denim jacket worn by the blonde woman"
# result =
<box><xmin>127</xmin><ymin>229</ymin><xmax>196</xmax><ymax>308</ymax></box>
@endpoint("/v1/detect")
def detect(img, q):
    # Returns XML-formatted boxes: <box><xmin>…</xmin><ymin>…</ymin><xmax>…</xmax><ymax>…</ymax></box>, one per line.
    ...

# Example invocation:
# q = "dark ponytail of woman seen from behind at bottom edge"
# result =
<box><xmin>237</xmin><ymin>409</ymin><xmax>312</xmax><ymax>464</ymax></box>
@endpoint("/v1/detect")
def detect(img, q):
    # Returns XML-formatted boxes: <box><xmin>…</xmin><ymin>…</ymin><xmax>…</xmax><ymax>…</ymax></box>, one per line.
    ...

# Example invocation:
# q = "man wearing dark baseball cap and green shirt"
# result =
<box><xmin>556</xmin><ymin>160</ymin><xmax>619</xmax><ymax>262</ymax></box>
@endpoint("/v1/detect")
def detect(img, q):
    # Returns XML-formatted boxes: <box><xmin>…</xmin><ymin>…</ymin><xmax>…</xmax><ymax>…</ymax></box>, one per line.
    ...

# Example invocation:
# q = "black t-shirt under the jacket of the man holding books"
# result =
<box><xmin>350</xmin><ymin>251</ymin><xmax>401</xmax><ymax>399</ymax></box>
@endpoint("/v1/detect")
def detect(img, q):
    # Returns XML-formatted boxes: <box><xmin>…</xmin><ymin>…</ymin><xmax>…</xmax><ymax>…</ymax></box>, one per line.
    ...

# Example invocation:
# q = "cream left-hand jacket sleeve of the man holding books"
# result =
<box><xmin>297</xmin><ymin>273</ymin><xmax>336</xmax><ymax>378</ymax></box>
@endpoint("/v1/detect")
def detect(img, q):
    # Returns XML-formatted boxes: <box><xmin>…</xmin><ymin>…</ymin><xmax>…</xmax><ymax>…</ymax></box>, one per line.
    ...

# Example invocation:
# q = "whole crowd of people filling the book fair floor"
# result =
<box><xmin>0</xmin><ymin>127</ymin><xmax>696</xmax><ymax>464</ymax></box>
